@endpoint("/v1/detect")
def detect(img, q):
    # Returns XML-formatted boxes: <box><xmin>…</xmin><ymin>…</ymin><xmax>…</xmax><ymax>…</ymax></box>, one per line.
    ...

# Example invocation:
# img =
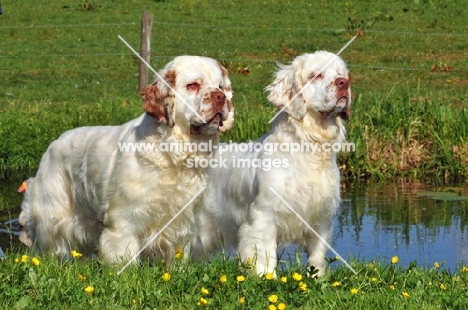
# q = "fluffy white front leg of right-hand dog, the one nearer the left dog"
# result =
<box><xmin>238</xmin><ymin>206</ymin><xmax>277</xmax><ymax>277</ymax></box>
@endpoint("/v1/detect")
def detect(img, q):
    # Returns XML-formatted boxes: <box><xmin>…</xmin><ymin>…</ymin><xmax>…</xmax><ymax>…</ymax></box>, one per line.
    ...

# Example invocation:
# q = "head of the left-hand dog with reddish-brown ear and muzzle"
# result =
<box><xmin>140</xmin><ymin>56</ymin><xmax>234</xmax><ymax>135</ymax></box>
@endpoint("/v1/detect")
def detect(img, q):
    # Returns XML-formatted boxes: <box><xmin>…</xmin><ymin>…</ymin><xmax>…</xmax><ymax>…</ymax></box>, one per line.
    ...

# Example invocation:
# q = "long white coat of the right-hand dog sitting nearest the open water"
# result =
<box><xmin>191</xmin><ymin>51</ymin><xmax>351</xmax><ymax>275</ymax></box>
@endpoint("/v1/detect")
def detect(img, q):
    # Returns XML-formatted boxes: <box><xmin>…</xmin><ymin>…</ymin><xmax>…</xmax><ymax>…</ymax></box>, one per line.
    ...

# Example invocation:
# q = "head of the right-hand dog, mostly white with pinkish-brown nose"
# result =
<box><xmin>265</xmin><ymin>51</ymin><xmax>351</xmax><ymax>120</ymax></box>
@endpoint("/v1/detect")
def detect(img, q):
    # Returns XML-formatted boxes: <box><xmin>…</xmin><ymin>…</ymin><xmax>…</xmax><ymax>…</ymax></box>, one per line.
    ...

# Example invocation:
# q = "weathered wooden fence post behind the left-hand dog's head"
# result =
<box><xmin>138</xmin><ymin>11</ymin><xmax>153</xmax><ymax>90</ymax></box>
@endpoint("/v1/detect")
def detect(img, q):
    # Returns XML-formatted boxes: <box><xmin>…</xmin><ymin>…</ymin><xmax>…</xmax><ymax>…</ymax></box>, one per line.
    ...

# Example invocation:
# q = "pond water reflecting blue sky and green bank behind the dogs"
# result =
<box><xmin>0</xmin><ymin>180</ymin><xmax>468</xmax><ymax>270</ymax></box>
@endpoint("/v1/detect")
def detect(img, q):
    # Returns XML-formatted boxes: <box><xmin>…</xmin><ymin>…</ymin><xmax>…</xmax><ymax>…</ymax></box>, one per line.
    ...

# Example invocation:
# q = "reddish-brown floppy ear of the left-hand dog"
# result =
<box><xmin>140</xmin><ymin>62</ymin><xmax>176</xmax><ymax>127</ymax></box>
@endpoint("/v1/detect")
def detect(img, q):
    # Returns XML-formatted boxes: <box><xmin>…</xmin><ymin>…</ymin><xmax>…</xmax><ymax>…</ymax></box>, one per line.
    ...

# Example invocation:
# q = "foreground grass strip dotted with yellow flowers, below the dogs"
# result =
<box><xmin>0</xmin><ymin>253</ymin><xmax>468</xmax><ymax>309</ymax></box>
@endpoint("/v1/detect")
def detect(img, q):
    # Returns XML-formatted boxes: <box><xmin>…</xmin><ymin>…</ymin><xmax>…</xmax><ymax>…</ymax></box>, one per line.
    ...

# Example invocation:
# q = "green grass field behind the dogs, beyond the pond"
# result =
<box><xmin>0</xmin><ymin>0</ymin><xmax>468</xmax><ymax>178</ymax></box>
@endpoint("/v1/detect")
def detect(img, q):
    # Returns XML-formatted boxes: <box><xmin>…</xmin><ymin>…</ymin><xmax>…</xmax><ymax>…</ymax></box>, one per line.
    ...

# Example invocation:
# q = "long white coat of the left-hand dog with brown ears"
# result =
<box><xmin>20</xmin><ymin>56</ymin><xmax>233</xmax><ymax>263</ymax></box>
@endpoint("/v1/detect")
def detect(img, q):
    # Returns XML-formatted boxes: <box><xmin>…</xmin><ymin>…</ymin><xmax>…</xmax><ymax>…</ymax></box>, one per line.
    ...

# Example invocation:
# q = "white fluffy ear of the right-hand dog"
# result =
<box><xmin>265</xmin><ymin>64</ymin><xmax>307</xmax><ymax>120</ymax></box>
